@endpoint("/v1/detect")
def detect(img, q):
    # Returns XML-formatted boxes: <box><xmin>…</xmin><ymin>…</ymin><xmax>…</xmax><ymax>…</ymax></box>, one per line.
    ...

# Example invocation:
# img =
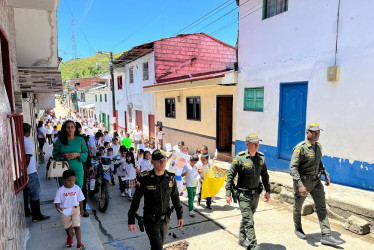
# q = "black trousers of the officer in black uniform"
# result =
<box><xmin>144</xmin><ymin>216</ymin><xmax>170</xmax><ymax>250</ymax></box>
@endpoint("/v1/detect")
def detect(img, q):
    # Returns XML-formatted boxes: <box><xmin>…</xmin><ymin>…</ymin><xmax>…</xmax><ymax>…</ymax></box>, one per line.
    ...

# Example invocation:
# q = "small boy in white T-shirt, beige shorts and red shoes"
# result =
<box><xmin>54</xmin><ymin>169</ymin><xmax>86</xmax><ymax>249</ymax></box>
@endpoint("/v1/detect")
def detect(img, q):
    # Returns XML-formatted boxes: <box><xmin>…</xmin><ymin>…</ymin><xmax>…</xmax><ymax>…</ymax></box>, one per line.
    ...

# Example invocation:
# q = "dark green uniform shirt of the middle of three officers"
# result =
<box><xmin>226</xmin><ymin>150</ymin><xmax>270</xmax><ymax>196</ymax></box>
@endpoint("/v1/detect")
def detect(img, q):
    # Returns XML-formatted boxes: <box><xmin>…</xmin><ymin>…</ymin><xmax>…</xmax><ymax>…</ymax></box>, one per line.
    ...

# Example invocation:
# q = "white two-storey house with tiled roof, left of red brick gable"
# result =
<box><xmin>108</xmin><ymin>43</ymin><xmax>155</xmax><ymax>140</ymax></box>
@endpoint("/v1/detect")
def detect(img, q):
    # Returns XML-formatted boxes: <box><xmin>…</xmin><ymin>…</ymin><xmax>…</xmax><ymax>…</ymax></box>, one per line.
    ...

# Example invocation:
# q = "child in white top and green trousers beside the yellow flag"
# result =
<box><xmin>182</xmin><ymin>155</ymin><xmax>200</xmax><ymax>217</ymax></box>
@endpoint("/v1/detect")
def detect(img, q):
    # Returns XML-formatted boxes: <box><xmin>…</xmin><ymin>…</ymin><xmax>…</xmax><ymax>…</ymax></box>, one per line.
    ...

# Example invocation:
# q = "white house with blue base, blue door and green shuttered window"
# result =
<box><xmin>235</xmin><ymin>0</ymin><xmax>374</xmax><ymax>190</ymax></box>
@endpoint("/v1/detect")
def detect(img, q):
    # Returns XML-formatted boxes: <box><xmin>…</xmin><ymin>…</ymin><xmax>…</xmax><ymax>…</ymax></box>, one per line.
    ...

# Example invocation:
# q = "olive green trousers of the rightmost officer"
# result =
<box><xmin>293</xmin><ymin>179</ymin><xmax>331</xmax><ymax>234</ymax></box>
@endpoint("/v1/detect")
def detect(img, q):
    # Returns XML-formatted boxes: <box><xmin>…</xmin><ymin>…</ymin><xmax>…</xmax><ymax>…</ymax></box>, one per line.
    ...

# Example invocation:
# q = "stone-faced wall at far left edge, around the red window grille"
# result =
<box><xmin>0</xmin><ymin>0</ymin><xmax>26</xmax><ymax>250</ymax></box>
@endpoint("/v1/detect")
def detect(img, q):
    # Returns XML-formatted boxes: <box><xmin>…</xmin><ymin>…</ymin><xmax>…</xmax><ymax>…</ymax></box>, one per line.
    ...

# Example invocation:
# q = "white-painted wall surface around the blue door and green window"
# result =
<box><xmin>236</xmin><ymin>0</ymin><xmax>374</xmax><ymax>189</ymax></box>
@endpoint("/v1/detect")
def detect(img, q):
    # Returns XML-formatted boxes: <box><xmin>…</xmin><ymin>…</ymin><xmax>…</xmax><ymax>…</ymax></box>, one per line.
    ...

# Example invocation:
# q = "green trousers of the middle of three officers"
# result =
<box><xmin>239</xmin><ymin>193</ymin><xmax>260</xmax><ymax>250</ymax></box>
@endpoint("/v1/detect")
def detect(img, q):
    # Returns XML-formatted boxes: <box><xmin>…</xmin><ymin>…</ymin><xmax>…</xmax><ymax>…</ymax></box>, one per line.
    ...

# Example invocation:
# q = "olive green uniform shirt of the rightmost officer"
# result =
<box><xmin>290</xmin><ymin>139</ymin><xmax>327</xmax><ymax>187</ymax></box>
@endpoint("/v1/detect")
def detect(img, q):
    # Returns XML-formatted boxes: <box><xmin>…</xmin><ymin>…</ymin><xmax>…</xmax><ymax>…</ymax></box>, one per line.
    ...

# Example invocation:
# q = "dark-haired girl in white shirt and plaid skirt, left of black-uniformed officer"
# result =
<box><xmin>120</xmin><ymin>152</ymin><xmax>137</xmax><ymax>201</ymax></box>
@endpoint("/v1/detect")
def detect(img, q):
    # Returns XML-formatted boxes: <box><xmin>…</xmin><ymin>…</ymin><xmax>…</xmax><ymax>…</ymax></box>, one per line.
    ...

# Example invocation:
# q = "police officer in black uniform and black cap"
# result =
<box><xmin>128</xmin><ymin>149</ymin><xmax>183</xmax><ymax>250</ymax></box>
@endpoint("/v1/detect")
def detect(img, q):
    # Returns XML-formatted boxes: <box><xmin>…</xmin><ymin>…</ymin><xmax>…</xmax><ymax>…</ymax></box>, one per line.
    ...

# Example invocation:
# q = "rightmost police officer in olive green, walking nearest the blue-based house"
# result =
<box><xmin>290</xmin><ymin>123</ymin><xmax>343</xmax><ymax>246</ymax></box>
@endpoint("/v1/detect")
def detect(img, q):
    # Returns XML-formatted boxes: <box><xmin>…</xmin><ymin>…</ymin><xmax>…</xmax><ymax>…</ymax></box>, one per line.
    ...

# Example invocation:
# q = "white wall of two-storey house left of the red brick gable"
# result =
<box><xmin>113</xmin><ymin>52</ymin><xmax>155</xmax><ymax>138</ymax></box>
